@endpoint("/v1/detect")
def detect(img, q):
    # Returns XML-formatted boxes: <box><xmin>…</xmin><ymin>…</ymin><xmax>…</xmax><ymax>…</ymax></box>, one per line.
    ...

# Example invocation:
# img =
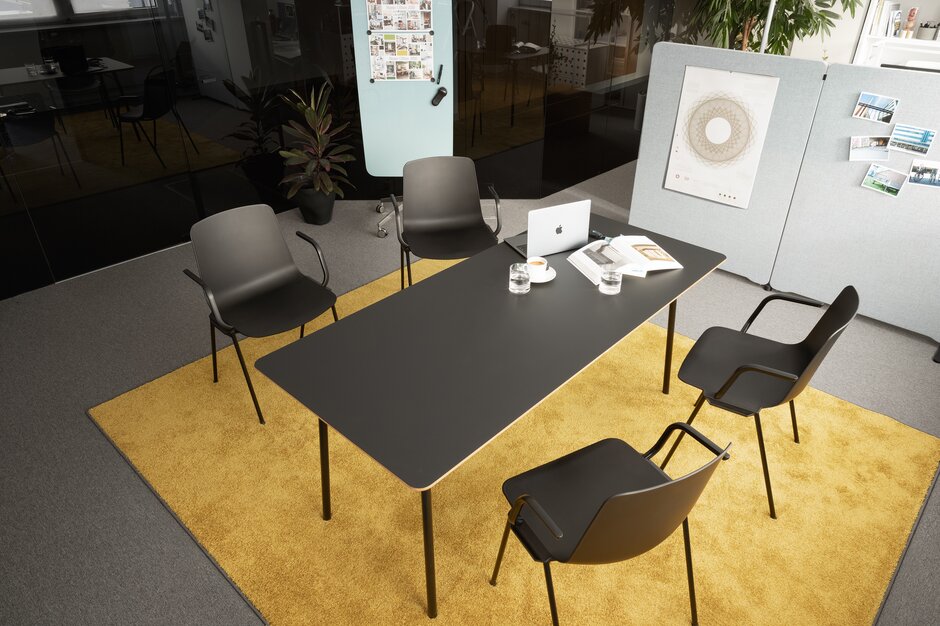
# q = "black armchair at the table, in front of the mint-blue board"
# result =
<box><xmin>391</xmin><ymin>156</ymin><xmax>502</xmax><ymax>289</ymax></box>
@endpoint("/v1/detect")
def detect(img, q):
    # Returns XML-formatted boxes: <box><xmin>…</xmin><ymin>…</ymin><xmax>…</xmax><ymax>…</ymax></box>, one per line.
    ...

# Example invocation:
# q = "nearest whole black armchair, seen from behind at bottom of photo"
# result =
<box><xmin>490</xmin><ymin>423</ymin><xmax>731</xmax><ymax>626</ymax></box>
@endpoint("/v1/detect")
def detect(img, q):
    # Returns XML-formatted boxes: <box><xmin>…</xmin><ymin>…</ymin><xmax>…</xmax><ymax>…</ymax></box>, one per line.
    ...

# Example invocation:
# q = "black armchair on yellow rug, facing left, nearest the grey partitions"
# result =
<box><xmin>662</xmin><ymin>285</ymin><xmax>858</xmax><ymax>519</ymax></box>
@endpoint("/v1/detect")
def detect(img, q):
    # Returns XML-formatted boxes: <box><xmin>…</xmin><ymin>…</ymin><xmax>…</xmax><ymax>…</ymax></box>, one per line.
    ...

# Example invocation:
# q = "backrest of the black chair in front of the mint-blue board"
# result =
<box><xmin>402</xmin><ymin>156</ymin><xmax>485</xmax><ymax>233</ymax></box>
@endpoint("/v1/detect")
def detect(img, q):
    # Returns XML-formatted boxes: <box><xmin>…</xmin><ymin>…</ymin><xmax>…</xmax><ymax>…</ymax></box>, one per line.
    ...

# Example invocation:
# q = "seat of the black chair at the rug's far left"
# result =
<box><xmin>219</xmin><ymin>272</ymin><xmax>336</xmax><ymax>337</ymax></box>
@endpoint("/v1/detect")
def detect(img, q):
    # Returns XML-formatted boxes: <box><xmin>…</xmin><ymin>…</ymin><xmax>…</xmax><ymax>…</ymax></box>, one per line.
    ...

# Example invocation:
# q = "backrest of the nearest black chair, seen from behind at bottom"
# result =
<box><xmin>567</xmin><ymin>444</ymin><xmax>731</xmax><ymax>563</ymax></box>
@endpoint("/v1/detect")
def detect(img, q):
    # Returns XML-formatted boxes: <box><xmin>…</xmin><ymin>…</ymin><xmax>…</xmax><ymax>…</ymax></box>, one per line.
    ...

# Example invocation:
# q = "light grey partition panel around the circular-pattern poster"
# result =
<box><xmin>630</xmin><ymin>43</ymin><xmax>826</xmax><ymax>284</ymax></box>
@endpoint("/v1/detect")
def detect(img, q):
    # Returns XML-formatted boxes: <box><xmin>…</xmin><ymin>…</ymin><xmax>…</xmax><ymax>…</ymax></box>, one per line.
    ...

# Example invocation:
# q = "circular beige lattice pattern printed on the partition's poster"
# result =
<box><xmin>686</xmin><ymin>94</ymin><xmax>753</xmax><ymax>166</ymax></box>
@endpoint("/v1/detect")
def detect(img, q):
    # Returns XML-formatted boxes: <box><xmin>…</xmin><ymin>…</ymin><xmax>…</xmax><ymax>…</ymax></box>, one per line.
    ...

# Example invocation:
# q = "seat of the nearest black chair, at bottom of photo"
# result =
<box><xmin>503</xmin><ymin>439</ymin><xmax>670</xmax><ymax>563</ymax></box>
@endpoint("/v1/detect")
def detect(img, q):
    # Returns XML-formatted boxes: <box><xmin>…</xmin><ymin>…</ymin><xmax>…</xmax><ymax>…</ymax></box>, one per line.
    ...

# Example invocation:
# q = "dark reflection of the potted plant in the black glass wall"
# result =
<box><xmin>222</xmin><ymin>72</ymin><xmax>284</xmax><ymax>207</ymax></box>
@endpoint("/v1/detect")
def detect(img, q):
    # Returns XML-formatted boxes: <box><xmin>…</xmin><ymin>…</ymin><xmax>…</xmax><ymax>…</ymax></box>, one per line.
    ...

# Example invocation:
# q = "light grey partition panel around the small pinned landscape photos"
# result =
<box><xmin>772</xmin><ymin>65</ymin><xmax>940</xmax><ymax>340</ymax></box>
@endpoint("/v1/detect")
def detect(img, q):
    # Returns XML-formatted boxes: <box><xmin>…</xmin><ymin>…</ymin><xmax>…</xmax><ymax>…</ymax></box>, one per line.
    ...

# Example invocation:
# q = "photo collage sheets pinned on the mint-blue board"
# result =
<box><xmin>366</xmin><ymin>0</ymin><xmax>434</xmax><ymax>81</ymax></box>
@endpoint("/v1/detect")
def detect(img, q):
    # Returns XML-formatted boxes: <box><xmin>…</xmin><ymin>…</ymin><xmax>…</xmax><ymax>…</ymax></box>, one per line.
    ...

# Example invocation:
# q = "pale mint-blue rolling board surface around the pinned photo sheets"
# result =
<box><xmin>351</xmin><ymin>0</ymin><xmax>457</xmax><ymax>177</ymax></box>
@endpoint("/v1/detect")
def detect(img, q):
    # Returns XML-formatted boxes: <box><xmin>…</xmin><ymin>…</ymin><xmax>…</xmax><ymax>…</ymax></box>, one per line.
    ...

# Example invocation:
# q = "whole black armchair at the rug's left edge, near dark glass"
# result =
<box><xmin>183</xmin><ymin>204</ymin><xmax>339</xmax><ymax>424</ymax></box>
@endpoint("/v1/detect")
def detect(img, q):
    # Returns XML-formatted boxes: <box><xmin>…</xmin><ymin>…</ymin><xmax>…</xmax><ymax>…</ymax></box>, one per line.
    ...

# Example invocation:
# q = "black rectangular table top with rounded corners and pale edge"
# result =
<box><xmin>256</xmin><ymin>216</ymin><xmax>725</xmax><ymax>491</ymax></box>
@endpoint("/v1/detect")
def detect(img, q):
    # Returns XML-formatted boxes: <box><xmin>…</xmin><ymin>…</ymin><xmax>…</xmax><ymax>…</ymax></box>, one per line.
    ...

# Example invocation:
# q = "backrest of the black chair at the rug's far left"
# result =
<box><xmin>189</xmin><ymin>204</ymin><xmax>300</xmax><ymax>308</ymax></box>
